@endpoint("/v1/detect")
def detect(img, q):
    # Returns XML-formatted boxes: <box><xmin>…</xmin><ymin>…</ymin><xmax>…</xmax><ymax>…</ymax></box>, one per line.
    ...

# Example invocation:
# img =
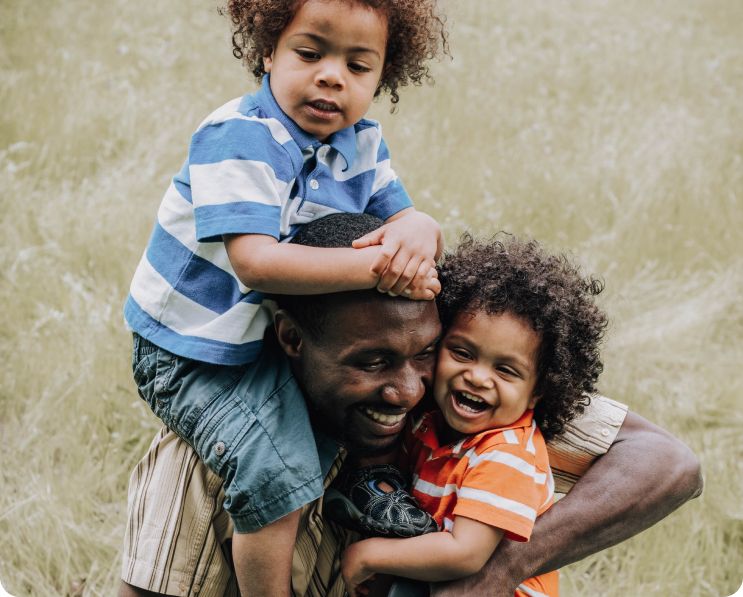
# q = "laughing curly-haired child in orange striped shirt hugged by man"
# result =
<box><xmin>343</xmin><ymin>238</ymin><xmax>606</xmax><ymax>596</ymax></box>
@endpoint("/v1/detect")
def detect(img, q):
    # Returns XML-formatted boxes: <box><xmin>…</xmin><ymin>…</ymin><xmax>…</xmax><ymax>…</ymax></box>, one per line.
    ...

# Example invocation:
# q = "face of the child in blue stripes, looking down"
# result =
<box><xmin>263</xmin><ymin>0</ymin><xmax>387</xmax><ymax>141</ymax></box>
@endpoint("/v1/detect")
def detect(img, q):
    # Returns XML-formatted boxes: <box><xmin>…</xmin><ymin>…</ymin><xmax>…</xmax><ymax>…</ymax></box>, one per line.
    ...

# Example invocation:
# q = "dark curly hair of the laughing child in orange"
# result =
<box><xmin>438</xmin><ymin>234</ymin><xmax>607</xmax><ymax>439</ymax></box>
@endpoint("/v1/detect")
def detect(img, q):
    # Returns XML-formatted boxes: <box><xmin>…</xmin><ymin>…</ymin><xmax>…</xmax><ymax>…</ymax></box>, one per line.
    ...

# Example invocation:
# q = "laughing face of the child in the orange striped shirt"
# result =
<box><xmin>434</xmin><ymin>311</ymin><xmax>541</xmax><ymax>435</ymax></box>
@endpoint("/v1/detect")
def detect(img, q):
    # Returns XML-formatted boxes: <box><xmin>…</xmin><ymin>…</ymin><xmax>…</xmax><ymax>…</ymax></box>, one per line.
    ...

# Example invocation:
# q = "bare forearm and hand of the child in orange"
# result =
<box><xmin>341</xmin><ymin>516</ymin><xmax>503</xmax><ymax>596</ymax></box>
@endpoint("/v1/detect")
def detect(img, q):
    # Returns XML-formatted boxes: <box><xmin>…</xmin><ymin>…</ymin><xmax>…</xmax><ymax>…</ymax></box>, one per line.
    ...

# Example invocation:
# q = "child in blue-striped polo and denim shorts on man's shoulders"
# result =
<box><xmin>125</xmin><ymin>0</ymin><xmax>446</xmax><ymax>594</ymax></box>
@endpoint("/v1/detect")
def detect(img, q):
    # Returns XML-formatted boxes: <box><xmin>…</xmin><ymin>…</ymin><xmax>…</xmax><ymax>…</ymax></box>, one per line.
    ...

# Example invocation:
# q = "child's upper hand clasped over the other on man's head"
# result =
<box><xmin>353</xmin><ymin>209</ymin><xmax>444</xmax><ymax>300</ymax></box>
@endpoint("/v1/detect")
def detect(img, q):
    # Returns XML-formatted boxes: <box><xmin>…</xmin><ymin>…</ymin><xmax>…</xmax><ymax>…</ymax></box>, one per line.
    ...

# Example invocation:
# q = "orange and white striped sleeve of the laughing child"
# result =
<box><xmin>453</xmin><ymin>444</ymin><xmax>552</xmax><ymax>541</ymax></box>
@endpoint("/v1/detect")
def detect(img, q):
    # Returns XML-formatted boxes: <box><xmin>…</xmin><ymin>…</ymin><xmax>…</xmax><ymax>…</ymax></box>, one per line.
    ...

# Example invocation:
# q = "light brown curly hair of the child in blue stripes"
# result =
<box><xmin>227</xmin><ymin>0</ymin><xmax>449</xmax><ymax>107</ymax></box>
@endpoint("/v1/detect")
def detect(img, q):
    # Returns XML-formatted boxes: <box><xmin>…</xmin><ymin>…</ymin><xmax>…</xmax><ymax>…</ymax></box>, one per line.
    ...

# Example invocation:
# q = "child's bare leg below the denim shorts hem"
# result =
<box><xmin>232</xmin><ymin>510</ymin><xmax>299</xmax><ymax>597</ymax></box>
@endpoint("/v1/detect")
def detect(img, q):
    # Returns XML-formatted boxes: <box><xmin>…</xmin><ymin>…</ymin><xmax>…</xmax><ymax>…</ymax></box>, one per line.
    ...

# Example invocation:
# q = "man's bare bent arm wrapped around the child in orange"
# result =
<box><xmin>431</xmin><ymin>412</ymin><xmax>702</xmax><ymax>597</ymax></box>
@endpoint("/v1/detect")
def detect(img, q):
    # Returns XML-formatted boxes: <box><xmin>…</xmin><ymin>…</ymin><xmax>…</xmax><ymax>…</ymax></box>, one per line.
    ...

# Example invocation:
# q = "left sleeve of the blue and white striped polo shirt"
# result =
<box><xmin>189</xmin><ymin>115</ymin><xmax>294</xmax><ymax>242</ymax></box>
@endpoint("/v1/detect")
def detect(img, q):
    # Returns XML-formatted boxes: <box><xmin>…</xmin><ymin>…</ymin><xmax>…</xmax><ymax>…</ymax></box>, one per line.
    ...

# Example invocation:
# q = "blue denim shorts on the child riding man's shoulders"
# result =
<box><xmin>132</xmin><ymin>333</ymin><xmax>323</xmax><ymax>533</ymax></box>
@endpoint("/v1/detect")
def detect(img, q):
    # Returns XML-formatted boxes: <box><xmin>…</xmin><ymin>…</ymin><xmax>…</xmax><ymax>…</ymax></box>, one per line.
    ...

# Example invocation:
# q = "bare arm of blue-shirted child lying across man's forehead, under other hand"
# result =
<box><xmin>224</xmin><ymin>234</ymin><xmax>441</xmax><ymax>299</ymax></box>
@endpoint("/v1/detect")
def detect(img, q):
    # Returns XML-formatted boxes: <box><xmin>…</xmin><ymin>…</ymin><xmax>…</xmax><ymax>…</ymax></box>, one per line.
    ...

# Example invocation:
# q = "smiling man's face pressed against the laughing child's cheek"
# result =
<box><xmin>295</xmin><ymin>291</ymin><xmax>441</xmax><ymax>454</ymax></box>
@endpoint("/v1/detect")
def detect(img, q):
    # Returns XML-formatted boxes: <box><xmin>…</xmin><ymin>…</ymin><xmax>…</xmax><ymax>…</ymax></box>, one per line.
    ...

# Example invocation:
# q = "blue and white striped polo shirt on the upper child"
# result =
<box><xmin>124</xmin><ymin>76</ymin><xmax>411</xmax><ymax>365</ymax></box>
